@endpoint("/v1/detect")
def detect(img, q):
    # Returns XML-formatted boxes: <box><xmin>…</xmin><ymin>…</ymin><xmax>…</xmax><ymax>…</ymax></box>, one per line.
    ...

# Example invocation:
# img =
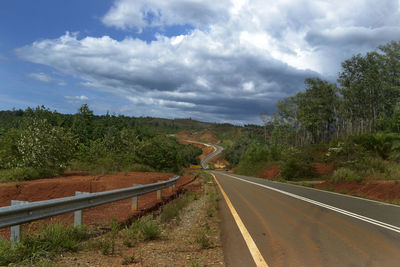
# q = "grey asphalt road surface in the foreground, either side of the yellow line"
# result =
<box><xmin>213</xmin><ymin>172</ymin><xmax>400</xmax><ymax>267</ymax></box>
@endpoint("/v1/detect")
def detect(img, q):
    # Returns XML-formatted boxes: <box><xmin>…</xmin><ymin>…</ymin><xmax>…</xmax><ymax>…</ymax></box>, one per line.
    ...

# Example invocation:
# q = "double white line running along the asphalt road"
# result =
<box><xmin>224</xmin><ymin>174</ymin><xmax>400</xmax><ymax>233</ymax></box>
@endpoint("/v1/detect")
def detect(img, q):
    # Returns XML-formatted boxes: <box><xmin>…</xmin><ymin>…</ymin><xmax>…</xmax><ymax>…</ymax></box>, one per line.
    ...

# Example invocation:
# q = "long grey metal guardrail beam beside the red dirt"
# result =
<box><xmin>0</xmin><ymin>176</ymin><xmax>179</xmax><ymax>228</ymax></box>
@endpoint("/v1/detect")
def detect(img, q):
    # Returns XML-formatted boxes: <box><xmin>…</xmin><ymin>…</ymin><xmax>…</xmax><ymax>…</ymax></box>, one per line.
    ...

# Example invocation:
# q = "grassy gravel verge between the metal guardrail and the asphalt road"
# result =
<box><xmin>0</xmin><ymin>172</ymin><xmax>223</xmax><ymax>266</ymax></box>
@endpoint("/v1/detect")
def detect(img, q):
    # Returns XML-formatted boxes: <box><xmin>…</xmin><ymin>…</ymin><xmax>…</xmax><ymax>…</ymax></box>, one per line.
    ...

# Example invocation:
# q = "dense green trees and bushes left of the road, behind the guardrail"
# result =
<box><xmin>0</xmin><ymin>104</ymin><xmax>202</xmax><ymax>181</ymax></box>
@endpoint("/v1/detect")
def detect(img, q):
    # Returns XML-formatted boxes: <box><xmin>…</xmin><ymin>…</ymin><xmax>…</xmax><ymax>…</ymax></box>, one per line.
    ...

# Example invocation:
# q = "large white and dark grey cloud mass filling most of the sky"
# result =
<box><xmin>16</xmin><ymin>0</ymin><xmax>400</xmax><ymax>122</ymax></box>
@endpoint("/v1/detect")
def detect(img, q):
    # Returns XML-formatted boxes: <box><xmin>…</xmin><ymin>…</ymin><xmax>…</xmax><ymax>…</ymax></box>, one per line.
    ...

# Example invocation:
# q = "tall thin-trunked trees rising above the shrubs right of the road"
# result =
<box><xmin>264</xmin><ymin>41</ymin><xmax>400</xmax><ymax>146</ymax></box>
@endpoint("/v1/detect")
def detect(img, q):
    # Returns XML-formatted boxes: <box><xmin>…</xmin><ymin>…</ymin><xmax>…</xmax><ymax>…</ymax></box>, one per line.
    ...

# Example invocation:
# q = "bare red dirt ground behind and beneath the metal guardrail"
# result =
<box><xmin>0</xmin><ymin>172</ymin><xmax>195</xmax><ymax>238</ymax></box>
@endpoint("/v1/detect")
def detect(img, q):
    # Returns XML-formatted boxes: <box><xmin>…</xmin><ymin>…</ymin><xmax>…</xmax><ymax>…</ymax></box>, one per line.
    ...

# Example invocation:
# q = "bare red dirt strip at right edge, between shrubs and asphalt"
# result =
<box><xmin>315</xmin><ymin>181</ymin><xmax>400</xmax><ymax>202</ymax></box>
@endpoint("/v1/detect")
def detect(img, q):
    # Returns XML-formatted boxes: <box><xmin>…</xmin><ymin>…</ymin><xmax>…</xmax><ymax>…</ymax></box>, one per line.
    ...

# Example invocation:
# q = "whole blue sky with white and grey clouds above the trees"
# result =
<box><xmin>0</xmin><ymin>0</ymin><xmax>400</xmax><ymax>125</ymax></box>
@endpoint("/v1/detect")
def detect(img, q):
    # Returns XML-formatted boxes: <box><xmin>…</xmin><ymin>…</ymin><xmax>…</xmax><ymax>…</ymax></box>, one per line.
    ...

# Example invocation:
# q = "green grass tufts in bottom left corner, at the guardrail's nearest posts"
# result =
<box><xmin>0</xmin><ymin>224</ymin><xmax>89</xmax><ymax>266</ymax></box>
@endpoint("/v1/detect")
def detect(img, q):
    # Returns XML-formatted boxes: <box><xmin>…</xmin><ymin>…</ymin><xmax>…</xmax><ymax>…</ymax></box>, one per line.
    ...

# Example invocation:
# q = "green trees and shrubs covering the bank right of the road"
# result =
<box><xmin>224</xmin><ymin>42</ymin><xmax>400</xmax><ymax>188</ymax></box>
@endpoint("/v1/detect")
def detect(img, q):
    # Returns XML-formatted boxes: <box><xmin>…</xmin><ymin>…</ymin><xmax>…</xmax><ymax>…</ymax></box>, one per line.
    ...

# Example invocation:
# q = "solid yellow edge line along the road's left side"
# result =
<box><xmin>211</xmin><ymin>174</ymin><xmax>268</xmax><ymax>267</ymax></box>
